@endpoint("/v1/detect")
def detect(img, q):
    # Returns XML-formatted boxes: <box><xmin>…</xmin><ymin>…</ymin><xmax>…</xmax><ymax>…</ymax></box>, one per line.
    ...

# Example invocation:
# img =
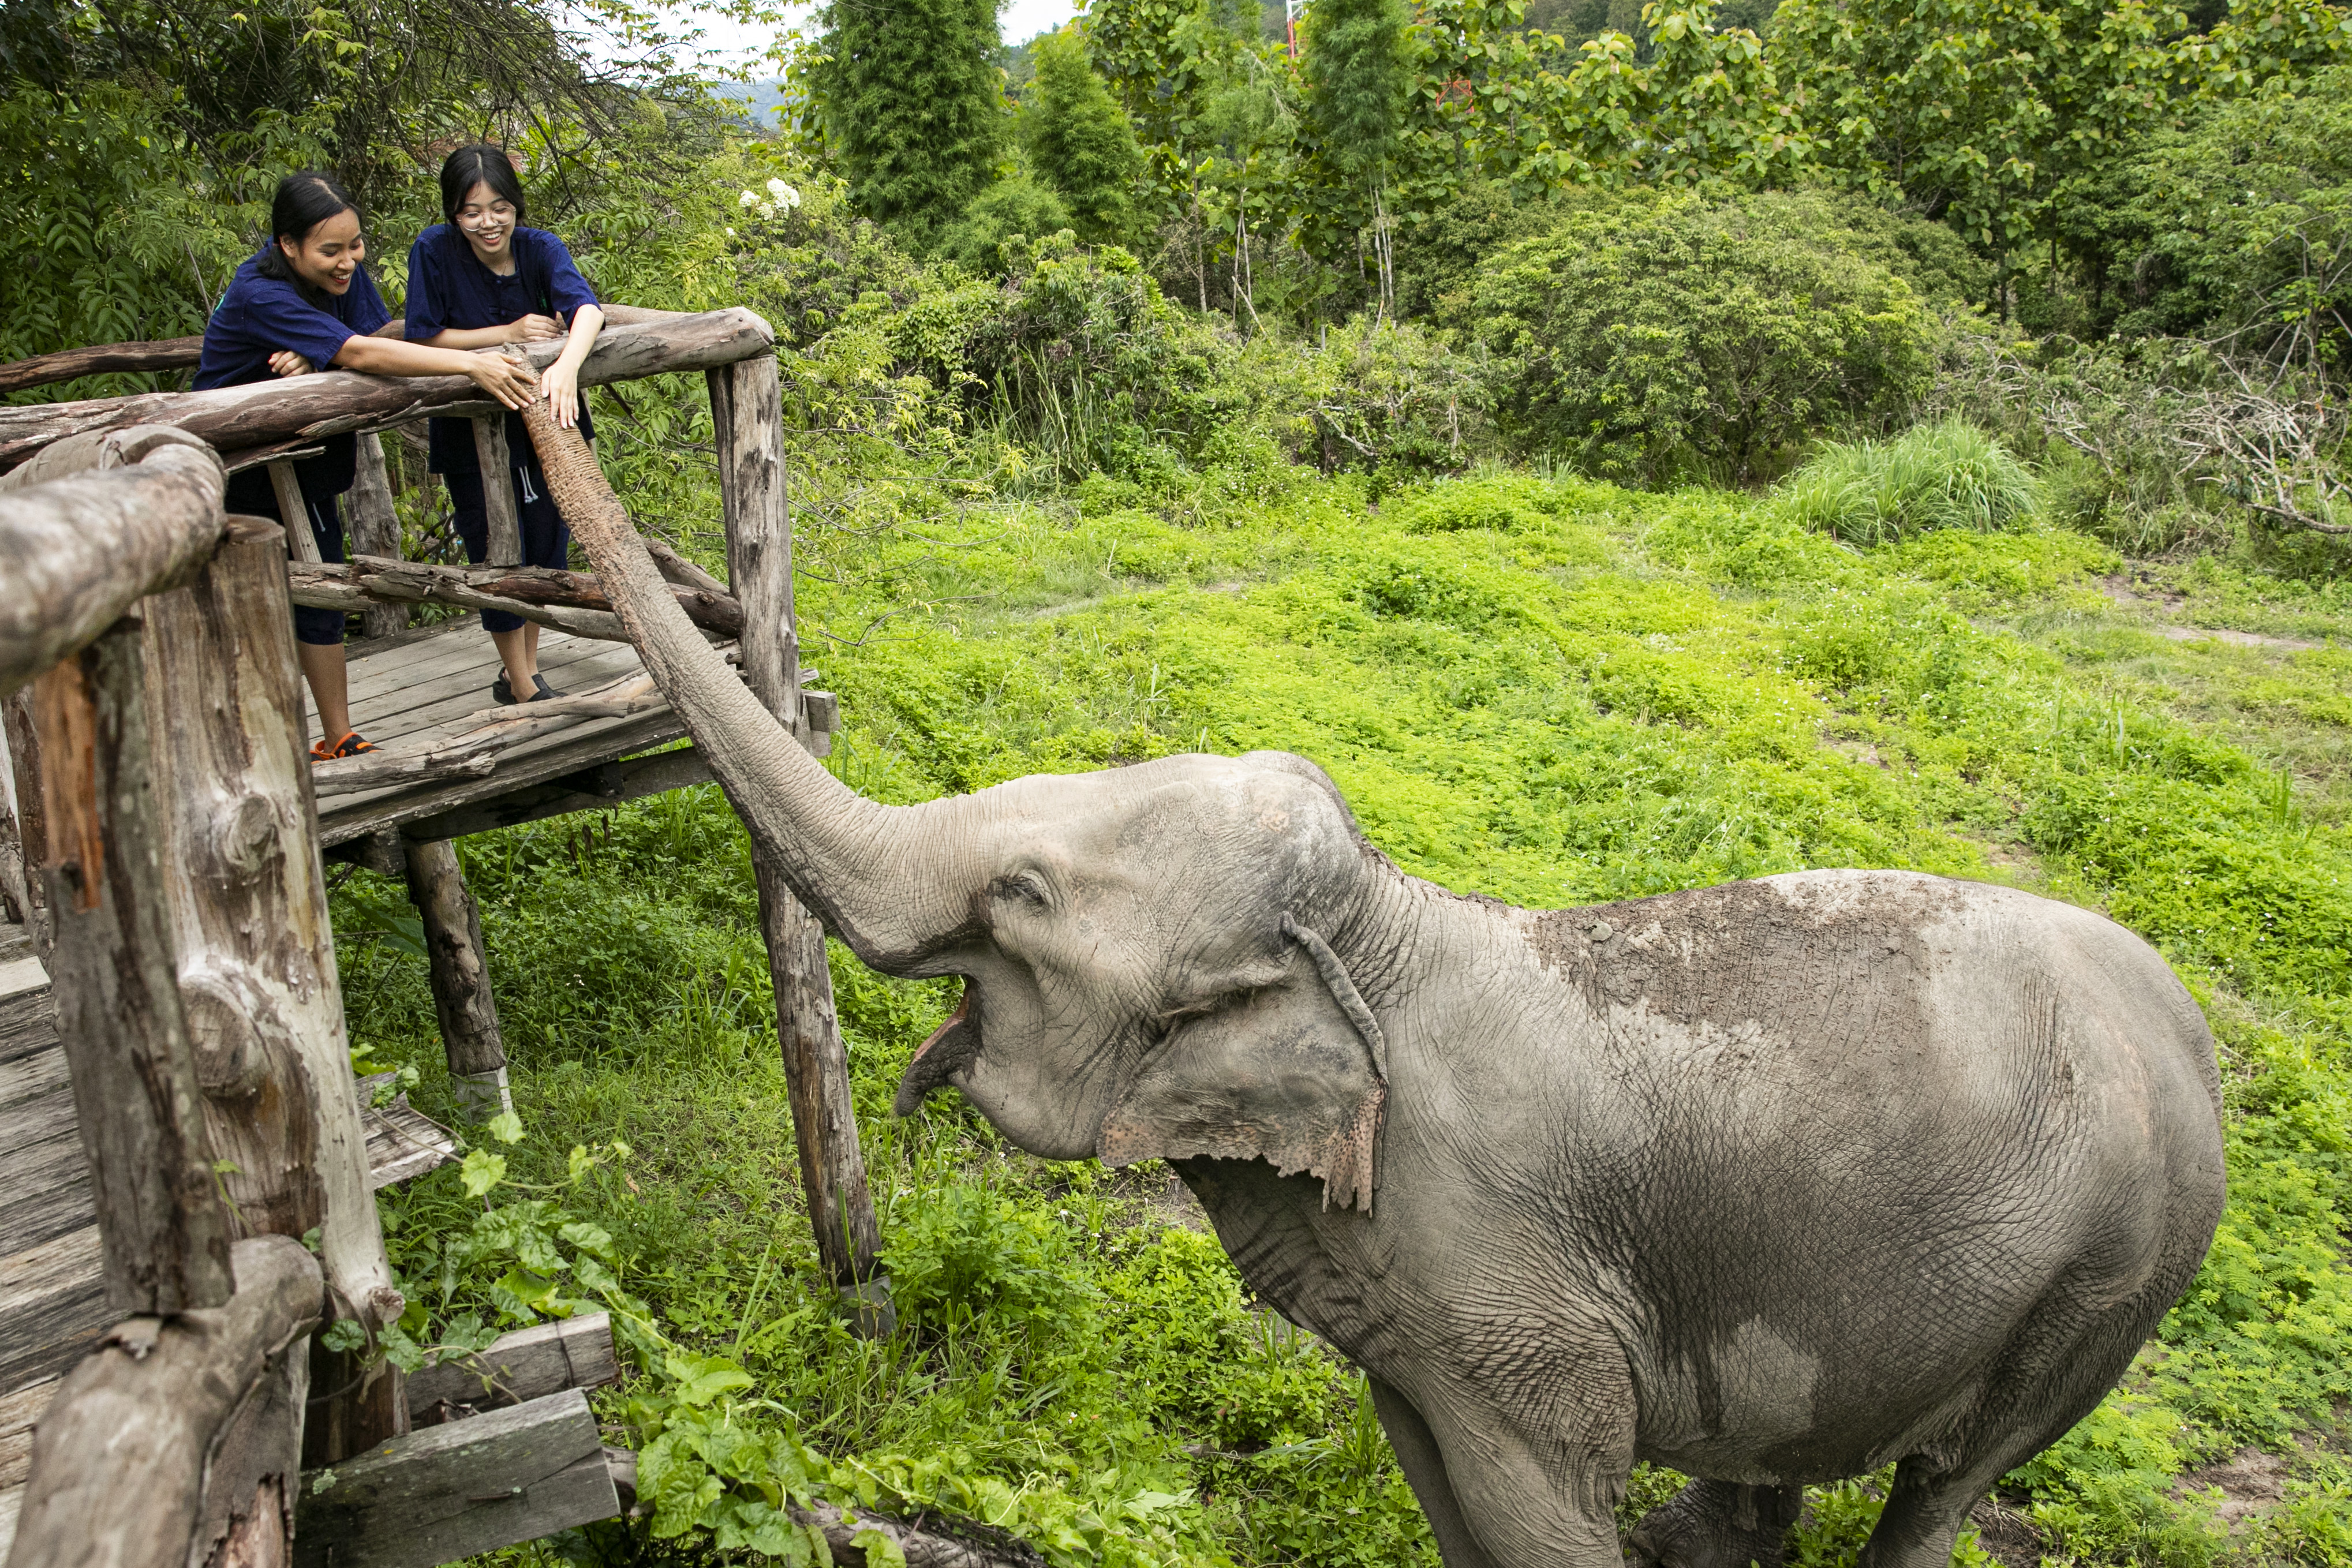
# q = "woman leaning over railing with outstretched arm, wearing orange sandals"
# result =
<box><xmin>195</xmin><ymin>169</ymin><xmax>534</xmax><ymax>762</ymax></box>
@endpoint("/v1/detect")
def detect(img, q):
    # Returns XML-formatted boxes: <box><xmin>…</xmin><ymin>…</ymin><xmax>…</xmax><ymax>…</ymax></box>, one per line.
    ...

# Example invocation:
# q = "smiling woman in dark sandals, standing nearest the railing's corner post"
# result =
<box><xmin>405</xmin><ymin>143</ymin><xmax>604</xmax><ymax>703</ymax></box>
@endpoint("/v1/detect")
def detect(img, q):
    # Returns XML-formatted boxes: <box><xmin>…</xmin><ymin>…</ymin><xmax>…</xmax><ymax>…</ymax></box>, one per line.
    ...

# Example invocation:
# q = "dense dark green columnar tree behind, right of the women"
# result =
<box><xmin>809</xmin><ymin>0</ymin><xmax>1004</xmax><ymax>245</ymax></box>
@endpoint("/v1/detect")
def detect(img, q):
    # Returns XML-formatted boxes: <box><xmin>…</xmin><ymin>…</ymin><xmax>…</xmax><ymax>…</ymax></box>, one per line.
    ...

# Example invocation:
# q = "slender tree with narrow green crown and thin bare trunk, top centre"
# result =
<box><xmin>1300</xmin><ymin>0</ymin><xmax>1414</xmax><ymax>313</ymax></box>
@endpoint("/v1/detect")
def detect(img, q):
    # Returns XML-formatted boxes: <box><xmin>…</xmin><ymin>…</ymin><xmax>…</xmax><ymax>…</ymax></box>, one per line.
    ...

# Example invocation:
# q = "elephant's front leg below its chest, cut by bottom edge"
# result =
<box><xmin>1371</xmin><ymin>1345</ymin><xmax>1635</xmax><ymax>1568</ymax></box>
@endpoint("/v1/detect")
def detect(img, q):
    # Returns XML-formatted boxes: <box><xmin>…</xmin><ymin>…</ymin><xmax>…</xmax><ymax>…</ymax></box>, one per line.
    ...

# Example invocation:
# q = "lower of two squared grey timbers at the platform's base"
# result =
<box><xmin>294</xmin><ymin>1389</ymin><xmax>621</xmax><ymax>1568</ymax></box>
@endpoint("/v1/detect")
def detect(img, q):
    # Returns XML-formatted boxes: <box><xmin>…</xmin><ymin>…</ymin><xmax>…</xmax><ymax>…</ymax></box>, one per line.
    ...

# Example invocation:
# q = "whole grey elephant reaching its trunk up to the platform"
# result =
<box><xmin>539</xmin><ymin>418</ymin><xmax>2223</xmax><ymax>1568</ymax></box>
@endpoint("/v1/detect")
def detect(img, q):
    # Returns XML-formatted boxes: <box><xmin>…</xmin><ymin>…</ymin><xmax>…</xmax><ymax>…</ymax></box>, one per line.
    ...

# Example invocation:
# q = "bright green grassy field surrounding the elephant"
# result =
<box><xmin>336</xmin><ymin>463</ymin><xmax>2352</xmax><ymax>1568</ymax></box>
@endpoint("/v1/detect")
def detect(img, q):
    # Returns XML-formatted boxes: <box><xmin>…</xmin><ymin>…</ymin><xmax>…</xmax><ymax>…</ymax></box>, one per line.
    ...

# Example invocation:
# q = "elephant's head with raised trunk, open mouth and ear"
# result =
<box><xmin>532</xmin><ymin>405</ymin><xmax>1394</xmax><ymax>1211</ymax></box>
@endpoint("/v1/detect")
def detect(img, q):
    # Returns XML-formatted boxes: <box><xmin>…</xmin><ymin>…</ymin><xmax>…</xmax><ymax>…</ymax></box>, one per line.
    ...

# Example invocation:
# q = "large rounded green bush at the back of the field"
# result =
<box><xmin>1446</xmin><ymin>193</ymin><xmax>1938</xmax><ymax>484</ymax></box>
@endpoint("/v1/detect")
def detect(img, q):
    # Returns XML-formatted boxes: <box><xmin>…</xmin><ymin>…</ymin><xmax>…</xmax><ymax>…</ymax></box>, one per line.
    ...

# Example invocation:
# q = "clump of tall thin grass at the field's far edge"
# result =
<box><xmin>1783</xmin><ymin>418</ymin><xmax>2041</xmax><ymax>545</ymax></box>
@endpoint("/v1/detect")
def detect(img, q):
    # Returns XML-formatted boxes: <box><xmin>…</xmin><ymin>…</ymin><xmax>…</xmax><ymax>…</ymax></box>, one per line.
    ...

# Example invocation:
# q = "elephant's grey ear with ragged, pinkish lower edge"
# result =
<box><xmin>1098</xmin><ymin>915</ymin><xmax>1388</xmax><ymax>1213</ymax></box>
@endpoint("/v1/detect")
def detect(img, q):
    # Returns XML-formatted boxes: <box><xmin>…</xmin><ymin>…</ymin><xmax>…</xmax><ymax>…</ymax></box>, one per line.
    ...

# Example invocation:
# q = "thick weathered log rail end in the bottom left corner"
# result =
<box><xmin>9</xmin><ymin>1237</ymin><xmax>322</xmax><ymax>1568</ymax></box>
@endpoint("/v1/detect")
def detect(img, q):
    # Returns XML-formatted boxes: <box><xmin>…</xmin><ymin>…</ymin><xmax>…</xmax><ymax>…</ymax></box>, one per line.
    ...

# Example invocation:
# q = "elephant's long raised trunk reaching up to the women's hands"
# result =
<box><xmin>522</xmin><ymin>397</ymin><xmax>960</xmax><ymax>968</ymax></box>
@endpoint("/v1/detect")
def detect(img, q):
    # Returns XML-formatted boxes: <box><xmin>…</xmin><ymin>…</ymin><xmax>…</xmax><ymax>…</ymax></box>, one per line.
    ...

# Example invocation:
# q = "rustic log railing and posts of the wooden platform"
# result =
<box><xmin>0</xmin><ymin>310</ymin><xmax>907</xmax><ymax>1568</ymax></box>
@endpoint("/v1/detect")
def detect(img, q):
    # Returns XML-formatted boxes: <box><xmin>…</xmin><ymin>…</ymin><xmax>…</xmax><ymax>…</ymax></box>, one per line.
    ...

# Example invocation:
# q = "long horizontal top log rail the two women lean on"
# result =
<box><xmin>0</xmin><ymin>308</ymin><xmax>776</xmax><ymax>470</ymax></box>
